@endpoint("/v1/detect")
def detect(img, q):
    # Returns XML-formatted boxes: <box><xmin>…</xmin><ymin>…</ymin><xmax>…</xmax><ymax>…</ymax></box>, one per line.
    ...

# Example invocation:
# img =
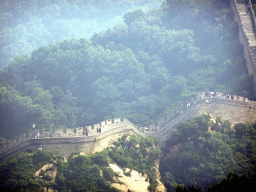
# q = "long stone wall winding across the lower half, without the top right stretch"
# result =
<box><xmin>0</xmin><ymin>93</ymin><xmax>256</xmax><ymax>161</ymax></box>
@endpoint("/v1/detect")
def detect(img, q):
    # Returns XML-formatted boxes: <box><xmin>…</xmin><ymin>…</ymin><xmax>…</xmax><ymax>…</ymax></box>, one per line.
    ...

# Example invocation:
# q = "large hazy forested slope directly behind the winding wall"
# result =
<box><xmin>0</xmin><ymin>0</ymin><xmax>254</xmax><ymax>138</ymax></box>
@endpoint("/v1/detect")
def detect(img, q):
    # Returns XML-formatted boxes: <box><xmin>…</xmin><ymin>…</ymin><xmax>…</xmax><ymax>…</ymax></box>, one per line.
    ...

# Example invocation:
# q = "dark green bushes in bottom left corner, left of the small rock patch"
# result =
<box><xmin>0</xmin><ymin>151</ymin><xmax>56</xmax><ymax>191</ymax></box>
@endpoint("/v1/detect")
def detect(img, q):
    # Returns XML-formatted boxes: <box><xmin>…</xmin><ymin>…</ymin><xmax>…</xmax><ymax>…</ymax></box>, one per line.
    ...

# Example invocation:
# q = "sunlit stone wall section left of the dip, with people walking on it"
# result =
<box><xmin>0</xmin><ymin>119</ymin><xmax>142</xmax><ymax>161</ymax></box>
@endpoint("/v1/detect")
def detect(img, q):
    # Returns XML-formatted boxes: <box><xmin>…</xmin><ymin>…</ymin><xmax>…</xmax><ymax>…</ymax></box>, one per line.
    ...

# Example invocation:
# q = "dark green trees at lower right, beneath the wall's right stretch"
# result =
<box><xmin>160</xmin><ymin>115</ymin><xmax>256</xmax><ymax>191</ymax></box>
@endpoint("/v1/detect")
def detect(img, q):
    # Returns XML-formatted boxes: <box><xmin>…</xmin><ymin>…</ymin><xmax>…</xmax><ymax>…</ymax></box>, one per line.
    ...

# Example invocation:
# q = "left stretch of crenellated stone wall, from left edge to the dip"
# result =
<box><xmin>0</xmin><ymin>118</ymin><xmax>138</xmax><ymax>161</ymax></box>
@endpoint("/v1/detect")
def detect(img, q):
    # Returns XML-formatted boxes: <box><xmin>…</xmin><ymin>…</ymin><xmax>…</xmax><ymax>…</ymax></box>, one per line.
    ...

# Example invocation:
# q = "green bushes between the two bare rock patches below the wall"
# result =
<box><xmin>55</xmin><ymin>151</ymin><xmax>122</xmax><ymax>191</ymax></box>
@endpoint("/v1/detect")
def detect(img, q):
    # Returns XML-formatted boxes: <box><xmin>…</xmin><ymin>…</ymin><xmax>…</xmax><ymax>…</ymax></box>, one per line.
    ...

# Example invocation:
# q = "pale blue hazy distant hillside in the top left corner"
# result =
<box><xmin>0</xmin><ymin>0</ymin><xmax>164</xmax><ymax>69</ymax></box>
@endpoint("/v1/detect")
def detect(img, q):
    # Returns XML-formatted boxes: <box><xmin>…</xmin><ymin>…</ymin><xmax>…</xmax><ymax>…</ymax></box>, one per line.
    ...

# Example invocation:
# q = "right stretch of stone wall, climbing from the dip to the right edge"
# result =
<box><xmin>146</xmin><ymin>95</ymin><xmax>256</xmax><ymax>146</ymax></box>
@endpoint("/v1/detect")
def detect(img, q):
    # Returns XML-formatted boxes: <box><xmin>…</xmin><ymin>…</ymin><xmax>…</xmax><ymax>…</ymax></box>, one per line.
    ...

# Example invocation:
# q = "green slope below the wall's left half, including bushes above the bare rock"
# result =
<box><xmin>0</xmin><ymin>135</ymin><xmax>162</xmax><ymax>192</ymax></box>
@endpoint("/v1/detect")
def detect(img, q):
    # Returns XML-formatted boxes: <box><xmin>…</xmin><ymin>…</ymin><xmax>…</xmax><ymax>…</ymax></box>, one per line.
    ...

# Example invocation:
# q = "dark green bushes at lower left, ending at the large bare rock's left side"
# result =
<box><xmin>0</xmin><ymin>151</ymin><xmax>119</xmax><ymax>192</ymax></box>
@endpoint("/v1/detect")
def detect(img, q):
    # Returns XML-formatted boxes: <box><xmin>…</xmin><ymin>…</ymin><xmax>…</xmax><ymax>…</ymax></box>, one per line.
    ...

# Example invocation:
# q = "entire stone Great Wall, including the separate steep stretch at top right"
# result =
<box><xmin>0</xmin><ymin>0</ymin><xmax>256</xmax><ymax>161</ymax></box>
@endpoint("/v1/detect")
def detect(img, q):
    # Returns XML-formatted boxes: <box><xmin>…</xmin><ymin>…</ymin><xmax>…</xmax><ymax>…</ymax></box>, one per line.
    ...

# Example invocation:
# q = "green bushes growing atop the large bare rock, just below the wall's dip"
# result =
<box><xmin>109</xmin><ymin>135</ymin><xmax>162</xmax><ymax>190</ymax></box>
